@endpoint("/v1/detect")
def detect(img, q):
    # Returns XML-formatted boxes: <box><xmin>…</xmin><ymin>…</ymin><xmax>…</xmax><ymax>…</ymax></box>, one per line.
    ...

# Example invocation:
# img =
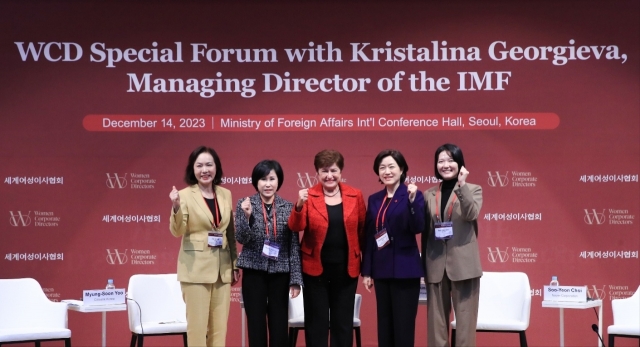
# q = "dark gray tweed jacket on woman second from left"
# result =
<box><xmin>236</xmin><ymin>194</ymin><xmax>302</xmax><ymax>286</ymax></box>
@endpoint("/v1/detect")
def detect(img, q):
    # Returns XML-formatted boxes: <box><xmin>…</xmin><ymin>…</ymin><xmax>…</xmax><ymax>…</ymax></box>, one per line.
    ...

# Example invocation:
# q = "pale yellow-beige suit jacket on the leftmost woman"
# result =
<box><xmin>170</xmin><ymin>185</ymin><xmax>238</xmax><ymax>283</ymax></box>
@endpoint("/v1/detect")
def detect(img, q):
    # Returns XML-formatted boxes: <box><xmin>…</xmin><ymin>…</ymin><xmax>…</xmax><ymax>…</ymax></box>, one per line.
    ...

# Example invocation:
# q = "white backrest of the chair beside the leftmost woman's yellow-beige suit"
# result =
<box><xmin>127</xmin><ymin>274</ymin><xmax>187</xmax><ymax>331</ymax></box>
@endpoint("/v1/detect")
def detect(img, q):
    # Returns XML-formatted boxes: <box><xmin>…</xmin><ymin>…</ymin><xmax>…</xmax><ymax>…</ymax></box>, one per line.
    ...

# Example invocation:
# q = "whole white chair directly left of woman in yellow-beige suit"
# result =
<box><xmin>127</xmin><ymin>274</ymin><xmax>187</xmax><ymax>347</ymax></box>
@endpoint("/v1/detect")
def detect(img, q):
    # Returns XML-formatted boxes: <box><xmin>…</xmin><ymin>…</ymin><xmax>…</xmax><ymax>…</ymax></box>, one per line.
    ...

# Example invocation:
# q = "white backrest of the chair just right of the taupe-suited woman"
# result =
<box><xmin>478</xmin><ymin>272</ymin><xmax>531</xmax><ymax>327</ymax></box>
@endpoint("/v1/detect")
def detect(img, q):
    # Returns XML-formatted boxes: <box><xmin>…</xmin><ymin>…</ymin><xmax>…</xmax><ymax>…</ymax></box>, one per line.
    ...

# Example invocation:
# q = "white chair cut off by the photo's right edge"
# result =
<box><xmin>607</xmin><ymin>286</ymin><xmax>640</xmax><ymax>347</ymax></box>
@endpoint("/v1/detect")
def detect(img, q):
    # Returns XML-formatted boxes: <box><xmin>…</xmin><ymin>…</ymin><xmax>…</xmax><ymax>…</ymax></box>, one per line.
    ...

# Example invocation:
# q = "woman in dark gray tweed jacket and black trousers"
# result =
<box><xmin>235</xmin><ymin>160</ymin><xmax>302</xmax><ymax>347</ymax></box>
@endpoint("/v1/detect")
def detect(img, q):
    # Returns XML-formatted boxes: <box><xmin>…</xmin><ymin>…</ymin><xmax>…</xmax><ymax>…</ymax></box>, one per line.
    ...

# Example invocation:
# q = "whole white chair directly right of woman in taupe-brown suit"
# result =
<box><xmin>451</xmin><ymin>272</ymin><xmax>531</xmax><ymax>347</ymax></box>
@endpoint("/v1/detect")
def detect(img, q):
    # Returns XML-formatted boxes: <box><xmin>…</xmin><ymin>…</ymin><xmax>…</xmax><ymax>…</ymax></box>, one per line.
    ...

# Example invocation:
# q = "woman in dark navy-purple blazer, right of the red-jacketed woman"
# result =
<box><xmin>362</xmin><ymin>150</ymin><xmax>425</xmax><ymax>347</ymax></box>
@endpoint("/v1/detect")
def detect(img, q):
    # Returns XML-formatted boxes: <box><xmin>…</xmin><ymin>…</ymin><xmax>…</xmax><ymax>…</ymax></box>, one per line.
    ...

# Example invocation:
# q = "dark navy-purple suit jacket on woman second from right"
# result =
<box><xmin>362</xmin><ymin>184</ymin><xmax>425</xmax><ymax>279</ymax></box>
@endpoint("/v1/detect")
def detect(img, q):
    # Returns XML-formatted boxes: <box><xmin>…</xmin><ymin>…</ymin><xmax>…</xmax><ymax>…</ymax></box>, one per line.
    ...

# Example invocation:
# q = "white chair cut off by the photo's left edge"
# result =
<box><xmin>0</xmin><ymin>278</ymin><xmax>71</xmax><ymax>347</ymax></box>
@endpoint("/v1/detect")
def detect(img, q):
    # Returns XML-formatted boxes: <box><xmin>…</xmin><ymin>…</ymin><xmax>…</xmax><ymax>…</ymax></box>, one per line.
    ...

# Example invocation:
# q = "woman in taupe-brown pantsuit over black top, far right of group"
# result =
<box><xmin>423</xmin><ymin>144</ymin><xmax>482</xmax><ymax>347</ymax></box>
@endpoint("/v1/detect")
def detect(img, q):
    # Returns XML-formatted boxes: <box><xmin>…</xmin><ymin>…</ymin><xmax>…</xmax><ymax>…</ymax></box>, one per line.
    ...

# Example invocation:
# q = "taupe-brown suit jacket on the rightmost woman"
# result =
<box><xmin>423</xmin><ymin>183</ymin><xmax>482</xmax><ymax>283</ymax></box>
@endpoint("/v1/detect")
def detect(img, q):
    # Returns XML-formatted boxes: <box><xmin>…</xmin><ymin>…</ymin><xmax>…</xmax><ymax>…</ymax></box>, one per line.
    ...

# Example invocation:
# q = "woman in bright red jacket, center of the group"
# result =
<box><xmin>289</xmin><ymin>150</ymin><xmax>366</xmax><ymax>347</ymax></box>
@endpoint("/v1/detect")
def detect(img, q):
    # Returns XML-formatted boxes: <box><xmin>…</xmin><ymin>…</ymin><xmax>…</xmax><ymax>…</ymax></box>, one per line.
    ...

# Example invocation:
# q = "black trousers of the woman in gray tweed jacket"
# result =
<box><xmin>242</xmin><ymin>269</ymin><xmax>289</xmax><ymax>347</ymax></box>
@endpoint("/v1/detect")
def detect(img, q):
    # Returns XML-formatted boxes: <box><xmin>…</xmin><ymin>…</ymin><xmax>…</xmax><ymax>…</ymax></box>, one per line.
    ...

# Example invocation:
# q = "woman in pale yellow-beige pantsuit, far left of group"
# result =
<box><xmin>169</xmin><ymin>146</ymin><xmax>240</xmax><ymax>347</ymax></box>
